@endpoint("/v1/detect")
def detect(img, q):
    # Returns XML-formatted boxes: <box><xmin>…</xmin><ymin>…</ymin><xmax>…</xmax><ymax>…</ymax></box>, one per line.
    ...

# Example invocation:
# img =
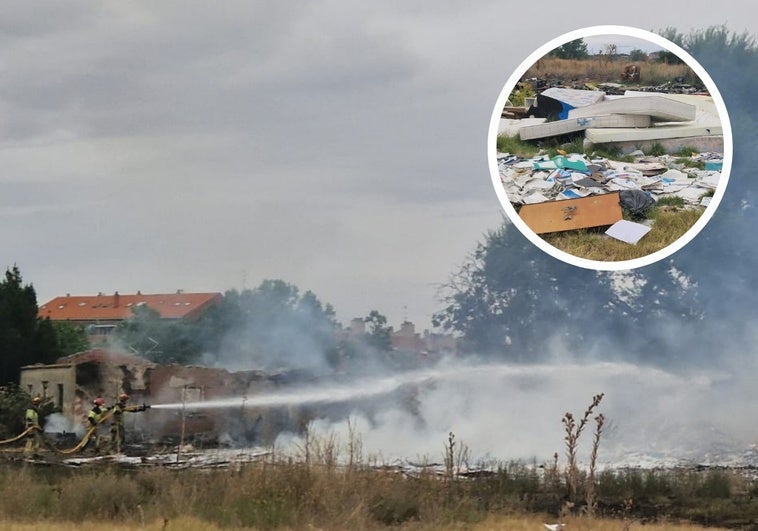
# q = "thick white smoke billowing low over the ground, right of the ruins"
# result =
<box><xmin>276</xmin><ymin>363</ymin><xmax>758</xmax><ymax>464</ymax></box>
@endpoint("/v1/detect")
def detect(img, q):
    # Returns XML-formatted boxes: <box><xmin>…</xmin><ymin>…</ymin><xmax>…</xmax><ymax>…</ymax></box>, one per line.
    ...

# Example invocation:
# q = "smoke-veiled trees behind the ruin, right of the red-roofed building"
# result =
<box><xmin>113</xmin><ymin>280</ymin><xmax>338</xmax><ymax>369</ymax></box>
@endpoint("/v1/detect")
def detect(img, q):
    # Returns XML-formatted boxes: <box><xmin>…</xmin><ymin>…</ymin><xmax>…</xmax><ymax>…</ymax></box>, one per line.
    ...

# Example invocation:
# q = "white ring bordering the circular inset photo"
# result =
<box><xmin>487</xmin><ymin>26</ymin><xmax>732</xmax><ymax>271</ymax></box>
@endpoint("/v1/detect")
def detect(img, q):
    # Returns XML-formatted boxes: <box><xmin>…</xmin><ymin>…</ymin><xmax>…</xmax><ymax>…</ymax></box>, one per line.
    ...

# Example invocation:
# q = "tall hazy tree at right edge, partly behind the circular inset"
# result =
<box><xmin>664</xmin><ymin>26</ymin><xmax>758</xmax><ymax>338</ymax></box>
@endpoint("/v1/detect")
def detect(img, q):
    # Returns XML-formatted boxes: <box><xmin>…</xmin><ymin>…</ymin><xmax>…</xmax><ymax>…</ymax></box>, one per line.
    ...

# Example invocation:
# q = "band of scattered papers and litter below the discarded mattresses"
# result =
<box><xmin>497</xmin><ymin>151</ymin><xmax>723</xmax><ymax>207</ymax></box>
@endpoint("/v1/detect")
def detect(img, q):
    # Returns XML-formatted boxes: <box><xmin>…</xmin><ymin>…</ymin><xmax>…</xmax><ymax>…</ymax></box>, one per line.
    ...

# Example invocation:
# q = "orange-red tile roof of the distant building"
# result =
<box><xmin>37</xmin><ymin>292</ymin><xmax>222</xmax><ymax>321</ymax></box>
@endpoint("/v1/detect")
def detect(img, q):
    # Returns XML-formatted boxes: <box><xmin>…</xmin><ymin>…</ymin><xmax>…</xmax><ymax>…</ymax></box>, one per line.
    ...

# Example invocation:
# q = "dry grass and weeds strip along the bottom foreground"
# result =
<box><xmin>0</xmin><ymin>460</ymin><xmax>758</xmax><ymax>531</ymax></box>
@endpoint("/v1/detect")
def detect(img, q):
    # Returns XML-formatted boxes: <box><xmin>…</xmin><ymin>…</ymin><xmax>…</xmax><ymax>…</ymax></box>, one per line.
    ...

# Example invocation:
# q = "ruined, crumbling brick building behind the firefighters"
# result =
<box><xmin>20</xmin><ymin>349</ymin><xmax>297</xmax><ymax>444</ymax></box>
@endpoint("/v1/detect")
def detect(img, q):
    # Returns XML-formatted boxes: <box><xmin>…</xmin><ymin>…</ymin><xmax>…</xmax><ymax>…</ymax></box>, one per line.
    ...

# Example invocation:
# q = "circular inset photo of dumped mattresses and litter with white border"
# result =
<box><xmin>488</xmin><ymin>26</ymin><xmax>732</xmax><ymax>270</ymax></box>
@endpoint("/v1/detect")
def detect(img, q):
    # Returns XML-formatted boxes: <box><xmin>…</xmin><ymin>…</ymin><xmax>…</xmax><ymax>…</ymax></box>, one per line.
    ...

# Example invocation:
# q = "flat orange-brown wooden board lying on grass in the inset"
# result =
<box><xmin>519</xmin><ymin>193</ymin><xmax>622</xmax><ymax>234</ymax></box>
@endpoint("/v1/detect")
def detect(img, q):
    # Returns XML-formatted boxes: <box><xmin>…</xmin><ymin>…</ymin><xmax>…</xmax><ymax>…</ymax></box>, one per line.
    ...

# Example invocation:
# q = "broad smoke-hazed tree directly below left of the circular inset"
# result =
<box><xmin>432</xmin><ymin>223</ymin><xmax>597</xmax><ymax>361</ymax></box>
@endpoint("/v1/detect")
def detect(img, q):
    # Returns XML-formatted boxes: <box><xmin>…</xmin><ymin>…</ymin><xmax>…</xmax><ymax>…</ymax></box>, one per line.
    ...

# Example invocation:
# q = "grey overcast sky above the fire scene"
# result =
<box><xmin>0</xmin><ymin>0</ymin><xmax>758</xmax><ymax>329</ymax></box>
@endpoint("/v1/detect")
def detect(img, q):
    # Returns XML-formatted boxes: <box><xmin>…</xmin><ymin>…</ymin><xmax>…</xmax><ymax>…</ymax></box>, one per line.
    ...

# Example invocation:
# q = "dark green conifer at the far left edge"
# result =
<box><xmin>0</xmin><ymin>265</ymin><xmax>57</xmax><ymax>384</ymax></box>
